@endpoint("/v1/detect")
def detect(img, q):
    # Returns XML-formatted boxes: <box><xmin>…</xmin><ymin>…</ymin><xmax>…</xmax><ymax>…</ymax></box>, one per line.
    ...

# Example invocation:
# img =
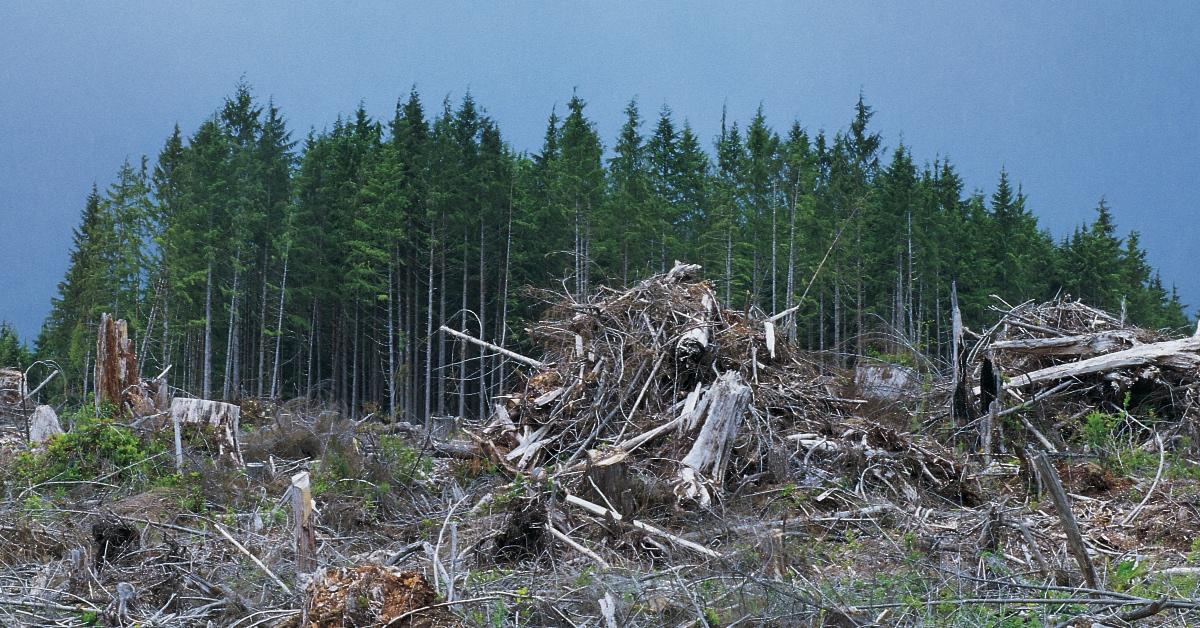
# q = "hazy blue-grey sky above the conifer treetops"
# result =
<box><xmin>0</xmin><ymin>1</ymin><xmax>1200</xmax><ymax>340</ymax></box>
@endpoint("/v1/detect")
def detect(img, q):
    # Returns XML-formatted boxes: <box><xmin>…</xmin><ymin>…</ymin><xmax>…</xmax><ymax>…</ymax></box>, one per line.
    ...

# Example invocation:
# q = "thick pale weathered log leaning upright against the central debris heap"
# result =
<box><xmin>676</xmin><ymin>371</ymin><xmax>750</xmax><ymax>506</ymax></box>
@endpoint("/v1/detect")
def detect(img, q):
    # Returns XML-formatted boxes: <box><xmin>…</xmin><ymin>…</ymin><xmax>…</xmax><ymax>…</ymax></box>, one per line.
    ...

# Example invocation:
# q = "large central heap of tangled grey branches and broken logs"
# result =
<box><xmin>453</xmin><ymin>263</ymin><xmax>976</xmax><ymax>533</ymax></box>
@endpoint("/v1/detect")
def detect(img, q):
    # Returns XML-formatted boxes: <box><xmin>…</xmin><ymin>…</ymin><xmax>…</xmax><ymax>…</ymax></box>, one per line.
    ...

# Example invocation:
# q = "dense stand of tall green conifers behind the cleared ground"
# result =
<box><xmin>28</xmin><ymin>84</ymin><xmax>1188</xmax><ymax>418</ymax></box>
